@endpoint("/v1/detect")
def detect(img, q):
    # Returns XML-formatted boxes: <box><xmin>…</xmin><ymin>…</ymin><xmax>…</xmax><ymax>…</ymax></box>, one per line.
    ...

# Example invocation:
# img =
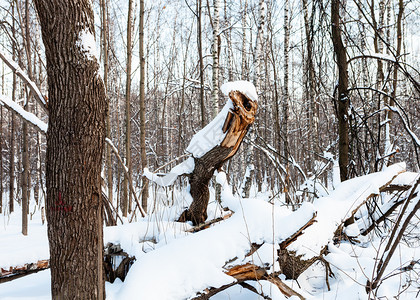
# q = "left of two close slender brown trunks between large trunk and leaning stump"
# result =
<box><xmin>121</xmin><ymin>0</ymin><xmax>133</xmax><ymax>217</ymax></box>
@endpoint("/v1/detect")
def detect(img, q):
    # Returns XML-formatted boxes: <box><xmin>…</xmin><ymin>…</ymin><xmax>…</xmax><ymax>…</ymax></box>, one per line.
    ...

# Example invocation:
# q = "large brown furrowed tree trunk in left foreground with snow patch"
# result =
<box><xmin>35</xmin><ymin>0</ymin><xmax>107</xmax><ymax>299</ymax></box>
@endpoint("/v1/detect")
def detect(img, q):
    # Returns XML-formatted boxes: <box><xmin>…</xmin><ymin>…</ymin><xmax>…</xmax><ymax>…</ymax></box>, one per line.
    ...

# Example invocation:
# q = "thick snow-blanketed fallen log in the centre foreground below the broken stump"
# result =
<box><xmin>119</xmin><ymin>199</ymin><xmax>314</xmax><ymax>300</ymax></box>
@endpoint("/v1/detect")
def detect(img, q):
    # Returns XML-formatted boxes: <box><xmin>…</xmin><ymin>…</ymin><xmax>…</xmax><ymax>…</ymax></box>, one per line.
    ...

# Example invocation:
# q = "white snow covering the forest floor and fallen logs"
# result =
<box><xmin>0</xmin><ymin>164</ymin><xmax>420</xmax><ymax>300</ymax></box>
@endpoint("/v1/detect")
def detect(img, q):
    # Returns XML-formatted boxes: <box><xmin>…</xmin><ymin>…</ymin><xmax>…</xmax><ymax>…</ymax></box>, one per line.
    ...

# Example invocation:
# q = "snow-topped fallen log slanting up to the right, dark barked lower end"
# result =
<box><xmin>279</xmin><ymin>164</ymin><xmax>405</xmax><ymax>279</ymax></box>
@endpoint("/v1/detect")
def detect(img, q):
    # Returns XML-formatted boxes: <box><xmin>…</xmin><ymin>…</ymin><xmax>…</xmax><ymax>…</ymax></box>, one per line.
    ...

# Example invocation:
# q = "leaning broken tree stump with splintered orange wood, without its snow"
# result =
<box><xmin>178</xmin><ymin>91</ymin><xmax>258</xmax><ymax>225</ymax></box>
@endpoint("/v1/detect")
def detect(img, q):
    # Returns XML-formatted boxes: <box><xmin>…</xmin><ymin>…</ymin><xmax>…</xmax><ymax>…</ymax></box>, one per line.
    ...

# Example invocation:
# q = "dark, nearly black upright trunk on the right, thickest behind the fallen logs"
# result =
<box><xmin>331</xmin><ymin>0</ymin><xmax>350</xmax><ymax>181</ymax></box>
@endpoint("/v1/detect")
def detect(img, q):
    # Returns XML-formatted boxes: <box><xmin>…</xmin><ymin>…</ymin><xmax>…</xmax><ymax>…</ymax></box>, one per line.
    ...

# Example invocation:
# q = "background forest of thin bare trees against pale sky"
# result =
<box><xmin>0</xmin><ymin>0</ymin><xmax>420</xmax><ymax>219</ymax></box>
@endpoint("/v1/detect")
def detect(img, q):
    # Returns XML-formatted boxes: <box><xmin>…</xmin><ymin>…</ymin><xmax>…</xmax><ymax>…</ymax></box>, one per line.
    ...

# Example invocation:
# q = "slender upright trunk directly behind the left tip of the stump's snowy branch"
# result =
<box><xmin>139</xmin><ymin>0</ymin><xmax>149</xmax><ymax>212</ymax></box>
